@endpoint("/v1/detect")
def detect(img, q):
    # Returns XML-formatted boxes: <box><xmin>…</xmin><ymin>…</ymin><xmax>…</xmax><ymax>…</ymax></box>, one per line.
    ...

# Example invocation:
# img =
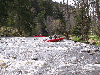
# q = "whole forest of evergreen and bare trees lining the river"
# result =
<box><xmin>0</xmin><ymin>0</ymin><xmax>100</xmax><ymax>44</ymax></box>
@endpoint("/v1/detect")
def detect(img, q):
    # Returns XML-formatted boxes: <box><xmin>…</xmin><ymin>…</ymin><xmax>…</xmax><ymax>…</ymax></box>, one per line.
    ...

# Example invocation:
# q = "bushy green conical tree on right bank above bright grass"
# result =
<box><xmin>72</xmin><ymin>7</ymin><xmax>90</xmax><ymax>36</ymax></box>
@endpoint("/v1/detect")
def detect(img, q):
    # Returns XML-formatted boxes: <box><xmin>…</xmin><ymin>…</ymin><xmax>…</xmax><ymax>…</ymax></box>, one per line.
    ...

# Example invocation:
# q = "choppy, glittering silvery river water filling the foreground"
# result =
<box><xmin>0</xmin><ymin>37</ymin><xmax>100</xmax><ymax>75</ymax></box>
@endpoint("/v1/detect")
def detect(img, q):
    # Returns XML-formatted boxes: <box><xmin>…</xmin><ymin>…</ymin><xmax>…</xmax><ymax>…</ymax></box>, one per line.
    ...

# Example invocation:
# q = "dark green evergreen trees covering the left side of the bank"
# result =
<box><xmin>0</xmin><ymin>0</ymin><xmax>66</xmax><ymax>35</ymax></box>
